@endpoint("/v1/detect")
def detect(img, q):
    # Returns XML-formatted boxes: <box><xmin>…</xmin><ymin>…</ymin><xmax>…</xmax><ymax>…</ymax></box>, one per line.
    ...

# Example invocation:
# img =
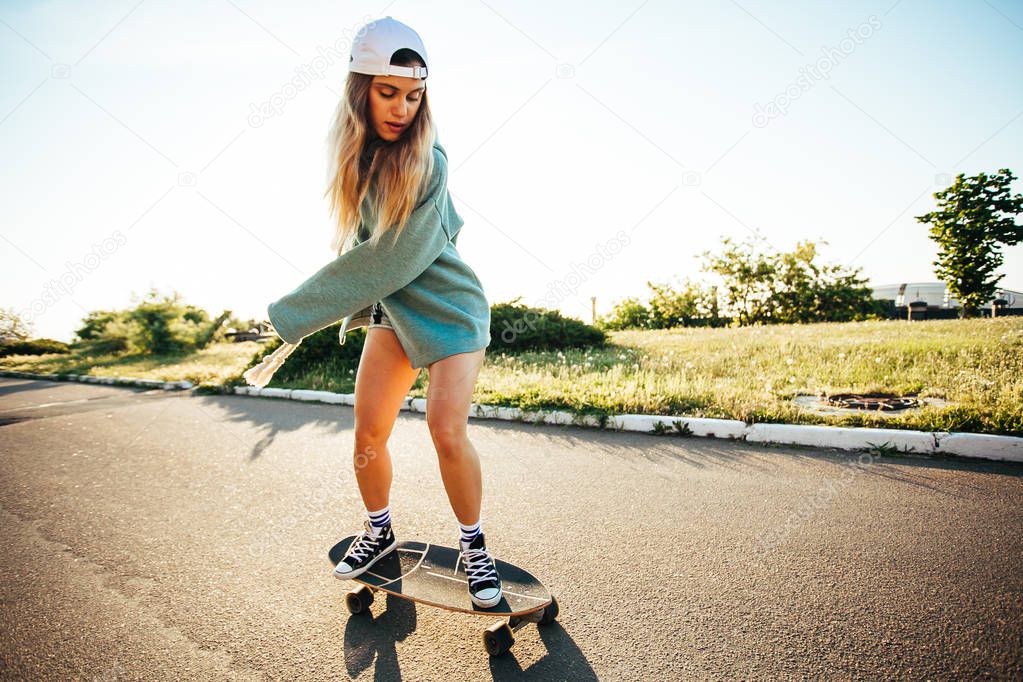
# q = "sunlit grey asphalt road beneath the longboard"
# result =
<box><xmin>0</xmin><ymin>378</ymin><xmax>1023</xmax><ymax>680</ymax></box>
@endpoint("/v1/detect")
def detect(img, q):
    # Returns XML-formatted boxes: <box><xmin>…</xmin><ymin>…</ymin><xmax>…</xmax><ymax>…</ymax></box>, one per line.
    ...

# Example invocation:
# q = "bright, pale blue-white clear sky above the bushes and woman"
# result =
<box><xmin>0</xmin><ymin>0</ymin><xmax>1023</xmax><ymax>340</ymax></box>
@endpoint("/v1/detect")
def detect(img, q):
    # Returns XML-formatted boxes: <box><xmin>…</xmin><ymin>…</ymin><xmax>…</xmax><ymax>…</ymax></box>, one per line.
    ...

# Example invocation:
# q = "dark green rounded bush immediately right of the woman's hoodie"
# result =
<box><xmin>488</xmin><ymin>299</ymin><xmax>608</xmax><ymax>353</ymax></box>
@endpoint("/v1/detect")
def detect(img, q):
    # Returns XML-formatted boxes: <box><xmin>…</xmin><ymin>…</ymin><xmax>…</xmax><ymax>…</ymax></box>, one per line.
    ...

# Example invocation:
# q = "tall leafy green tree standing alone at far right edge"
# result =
<box><xmin>916</xmin><ymin>168</ymin><xmax>1023</xmax><ymax>317</ymax></box>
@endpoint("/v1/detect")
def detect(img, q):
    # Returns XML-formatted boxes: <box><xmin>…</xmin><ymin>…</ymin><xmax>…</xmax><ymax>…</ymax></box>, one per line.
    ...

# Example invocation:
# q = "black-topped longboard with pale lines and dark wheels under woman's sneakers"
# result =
<box><xmin>327</xmin><ymin>535</ymin><xmax>558</xmax><ymax>655</ymax></box>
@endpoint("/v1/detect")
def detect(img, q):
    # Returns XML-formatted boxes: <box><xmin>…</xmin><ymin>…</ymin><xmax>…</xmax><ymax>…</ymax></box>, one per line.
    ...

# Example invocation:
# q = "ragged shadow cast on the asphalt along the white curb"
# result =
<box><xmin>6</xmin><ymin>377</ymin><xmax>1023</xmax><ymax>494</ymax></box>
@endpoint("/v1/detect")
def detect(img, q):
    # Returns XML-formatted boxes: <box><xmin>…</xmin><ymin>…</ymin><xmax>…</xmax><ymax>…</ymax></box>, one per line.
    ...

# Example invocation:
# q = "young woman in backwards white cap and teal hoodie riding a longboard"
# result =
<box><xmin>246</xmin><ymin>16</ymin><xmax>502</xmax><ymax>607</ymax></box>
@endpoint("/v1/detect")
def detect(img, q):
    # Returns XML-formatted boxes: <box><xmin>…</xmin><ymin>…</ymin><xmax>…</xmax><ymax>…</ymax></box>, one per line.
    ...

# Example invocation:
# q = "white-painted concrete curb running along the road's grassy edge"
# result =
<box><xmin>0</xmin><ymin>370</ymin><xmax>1023</xmax><ymax>462</ymax></box>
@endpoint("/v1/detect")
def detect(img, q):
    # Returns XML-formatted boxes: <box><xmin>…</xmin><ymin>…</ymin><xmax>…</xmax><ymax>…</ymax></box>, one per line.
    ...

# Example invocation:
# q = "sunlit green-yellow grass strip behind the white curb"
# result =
<box><xmin>0</xmin><ymin>317</ymin><xmax>1023</xmax><ymax>436</ymax></box>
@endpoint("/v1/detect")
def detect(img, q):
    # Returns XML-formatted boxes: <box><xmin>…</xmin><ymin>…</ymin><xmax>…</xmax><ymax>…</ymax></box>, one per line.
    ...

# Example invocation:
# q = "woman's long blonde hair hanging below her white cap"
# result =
<box><xmin>323</xmin><ymin>49</ymin><xmax>436</xmax><ymax>255</ymax></box>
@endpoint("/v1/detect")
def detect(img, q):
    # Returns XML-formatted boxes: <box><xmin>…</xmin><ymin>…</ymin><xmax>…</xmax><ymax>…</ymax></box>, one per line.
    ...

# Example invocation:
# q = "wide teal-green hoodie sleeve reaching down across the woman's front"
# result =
<box><xmin>267</xmin><ymin>147</ymin><xmax>448</xmax><ymax>344</ymax></box>
